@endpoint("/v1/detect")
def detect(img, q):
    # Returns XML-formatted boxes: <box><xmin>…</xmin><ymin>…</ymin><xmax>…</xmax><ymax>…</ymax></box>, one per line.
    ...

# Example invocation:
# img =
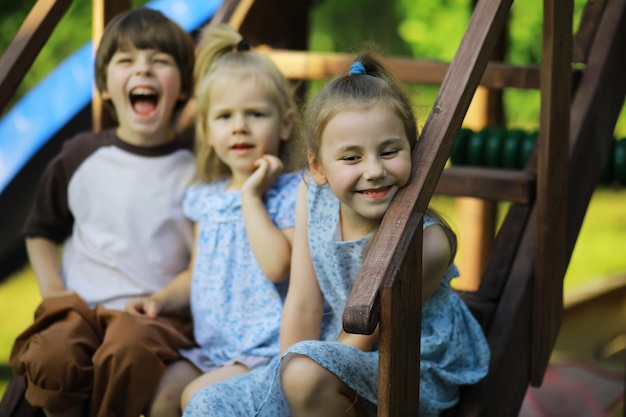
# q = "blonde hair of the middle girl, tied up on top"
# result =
<box><xmin>194</xmin><ymin>24</ymin><xmax>300</xmax><ymax>182</ymax></box>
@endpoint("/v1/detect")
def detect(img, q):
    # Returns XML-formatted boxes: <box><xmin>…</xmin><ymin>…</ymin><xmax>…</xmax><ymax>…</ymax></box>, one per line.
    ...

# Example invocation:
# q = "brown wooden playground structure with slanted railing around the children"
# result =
<box><xmin>0</xmin><ymin>0</ymin><xmax>626</xmax><ymax>417</ymax></box>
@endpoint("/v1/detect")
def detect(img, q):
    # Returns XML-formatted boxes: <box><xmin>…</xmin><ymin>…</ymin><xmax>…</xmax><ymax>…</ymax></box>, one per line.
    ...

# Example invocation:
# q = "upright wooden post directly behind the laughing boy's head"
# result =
<box><xmin>91</xmin><ymin>0</ymin><xmax>131</xmax><ymax>131</ymax></box>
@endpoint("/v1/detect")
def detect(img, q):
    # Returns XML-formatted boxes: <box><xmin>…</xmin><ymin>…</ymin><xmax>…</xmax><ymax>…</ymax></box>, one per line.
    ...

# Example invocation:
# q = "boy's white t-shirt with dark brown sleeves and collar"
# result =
<box><xmin>25</xmin><ymin>130</ymin><xmax>195</xmax><ymax>309</ymax></box>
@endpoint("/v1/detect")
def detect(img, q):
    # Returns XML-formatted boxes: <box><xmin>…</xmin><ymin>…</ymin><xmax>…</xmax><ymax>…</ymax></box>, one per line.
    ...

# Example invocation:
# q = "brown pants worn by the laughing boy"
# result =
<box><xmin>11</xmin><ymin>295</ymin><xmax>193</xmax><ymax>417</ymax></box>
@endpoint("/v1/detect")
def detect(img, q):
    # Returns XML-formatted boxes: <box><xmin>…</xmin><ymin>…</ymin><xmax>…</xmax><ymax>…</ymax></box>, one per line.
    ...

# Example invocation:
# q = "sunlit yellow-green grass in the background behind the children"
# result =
<box><xmin>0</xmin><ymin>188</ymin><xmax>626</xmax><ymax>395</ymax></box>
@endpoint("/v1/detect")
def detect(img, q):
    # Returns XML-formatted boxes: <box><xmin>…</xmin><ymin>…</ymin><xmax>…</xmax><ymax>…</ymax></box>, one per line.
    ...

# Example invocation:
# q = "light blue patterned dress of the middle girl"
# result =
<box><xmin>181</xmin><ymin>172</ymin><xmax>302</xmax><ymax>370</ymax></box>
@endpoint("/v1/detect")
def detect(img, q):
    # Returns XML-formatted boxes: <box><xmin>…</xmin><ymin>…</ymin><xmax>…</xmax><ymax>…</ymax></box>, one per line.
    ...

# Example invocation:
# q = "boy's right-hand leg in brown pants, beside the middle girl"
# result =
<box><xmin>91</xmin><ymin>308</ymin><xmax>192</xmax><ymax>417</ymax></box>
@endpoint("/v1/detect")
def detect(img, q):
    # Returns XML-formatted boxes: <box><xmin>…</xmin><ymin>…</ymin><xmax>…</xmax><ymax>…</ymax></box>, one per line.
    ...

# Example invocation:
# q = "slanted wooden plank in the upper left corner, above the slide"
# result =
<box><xmin>0</xmin><ymin>0</ymin><xmax>72</xmax><ymax>113</ymax></box>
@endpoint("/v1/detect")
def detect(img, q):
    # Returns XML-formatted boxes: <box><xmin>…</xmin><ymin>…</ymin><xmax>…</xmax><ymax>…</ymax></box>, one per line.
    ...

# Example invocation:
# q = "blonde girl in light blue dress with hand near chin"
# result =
<box><xmin>124</xmin><ymin>25</ymin><xmax>302</xmax><ymax>414</ymax></box>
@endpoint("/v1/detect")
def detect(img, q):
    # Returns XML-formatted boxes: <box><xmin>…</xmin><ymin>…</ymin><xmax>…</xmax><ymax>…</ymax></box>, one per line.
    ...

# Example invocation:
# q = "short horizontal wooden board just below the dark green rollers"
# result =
<box><xmin>435</xmin><ymin>166</ymin><xmax>535</xmax><ymax>204</ymax></box>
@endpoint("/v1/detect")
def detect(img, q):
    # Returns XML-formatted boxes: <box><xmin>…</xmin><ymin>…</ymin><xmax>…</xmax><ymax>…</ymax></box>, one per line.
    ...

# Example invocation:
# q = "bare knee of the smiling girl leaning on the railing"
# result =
<box><xmin>280</xmin><ymin>354</ymin><xmax>366</xmax><ymax>417</ymax></box>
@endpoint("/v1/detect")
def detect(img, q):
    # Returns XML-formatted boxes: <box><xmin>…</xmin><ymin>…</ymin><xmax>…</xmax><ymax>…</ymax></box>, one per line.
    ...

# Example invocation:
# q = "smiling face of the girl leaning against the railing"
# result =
<box><xmin>311</xmin><ymin>102</ymin><xmax>411</xmax><ymax>230</ymax></box>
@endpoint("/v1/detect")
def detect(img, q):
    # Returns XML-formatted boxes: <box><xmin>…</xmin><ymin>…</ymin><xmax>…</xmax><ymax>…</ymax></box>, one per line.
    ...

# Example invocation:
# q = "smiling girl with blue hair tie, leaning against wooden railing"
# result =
<box><xmin>180</xmin><ymin>50</ymin><xmax>489</xmax><ymax>417</ymax></box>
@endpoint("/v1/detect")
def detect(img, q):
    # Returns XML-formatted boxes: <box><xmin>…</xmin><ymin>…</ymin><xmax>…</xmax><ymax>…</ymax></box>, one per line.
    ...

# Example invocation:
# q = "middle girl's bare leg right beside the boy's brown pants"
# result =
<box><xmin>145</xmin><ymin>359</ymin><xmax>202</xmax><ymax>417</ymax></box>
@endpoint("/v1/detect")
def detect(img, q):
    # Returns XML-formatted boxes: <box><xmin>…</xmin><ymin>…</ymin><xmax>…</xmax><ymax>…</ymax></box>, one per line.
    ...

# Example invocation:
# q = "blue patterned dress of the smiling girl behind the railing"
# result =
<box><xmin>184</xmin><ymin>182</ymin><xmax>489</xmax><ymax>417</ymax></box>
